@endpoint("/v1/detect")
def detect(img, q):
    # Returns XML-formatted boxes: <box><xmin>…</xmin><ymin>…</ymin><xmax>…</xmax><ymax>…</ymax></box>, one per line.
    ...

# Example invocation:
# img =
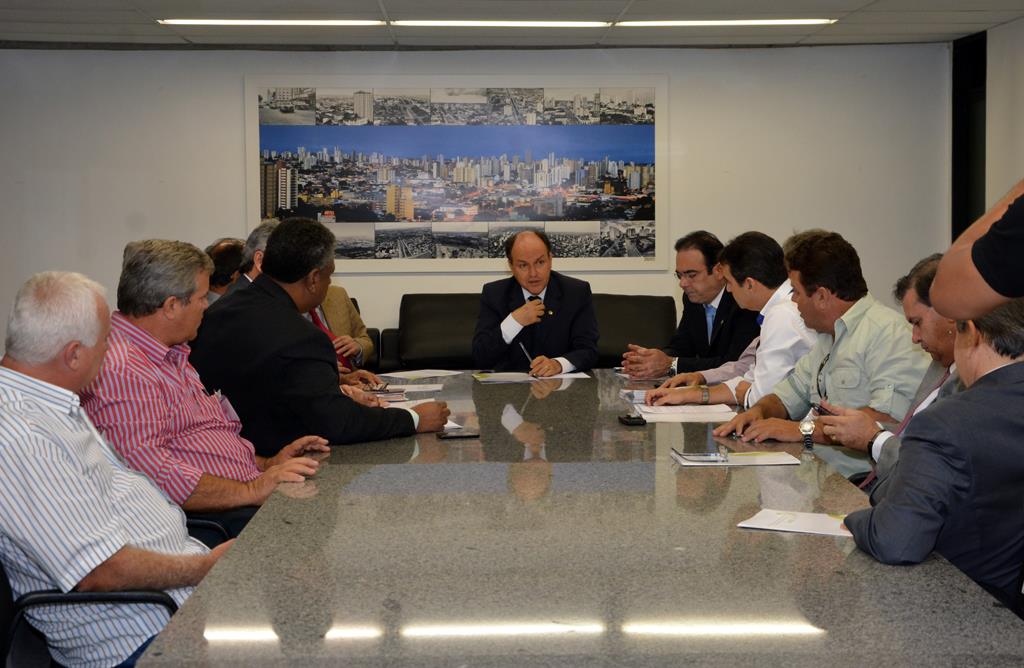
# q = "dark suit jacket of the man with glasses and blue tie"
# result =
<box><xmin>663</xmin><ymin>290</ymin><xmax>761</xmax><ymax>373</ymax></box>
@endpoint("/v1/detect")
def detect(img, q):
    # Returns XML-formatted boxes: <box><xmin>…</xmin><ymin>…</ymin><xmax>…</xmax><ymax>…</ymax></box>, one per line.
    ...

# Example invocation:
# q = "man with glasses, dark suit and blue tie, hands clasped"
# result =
<box><xmin>623</xmin><ymin>229</ymin><xmax>760</xmax><ymax>378</ymax></box>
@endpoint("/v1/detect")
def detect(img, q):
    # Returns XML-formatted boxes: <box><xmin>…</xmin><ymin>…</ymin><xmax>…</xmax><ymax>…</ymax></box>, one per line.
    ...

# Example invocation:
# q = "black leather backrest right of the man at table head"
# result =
<box><xmin>594</xmin><ymin>293</ymin><xmax>677</xmax><ymax>368</ymax></box>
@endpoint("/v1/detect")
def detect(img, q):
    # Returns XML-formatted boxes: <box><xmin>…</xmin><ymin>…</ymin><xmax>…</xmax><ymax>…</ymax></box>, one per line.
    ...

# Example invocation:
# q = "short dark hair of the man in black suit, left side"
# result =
<box><xmin>263</xmin><ymin>218</ymin><xmax>335</xmax><ymax>283</ymax></box>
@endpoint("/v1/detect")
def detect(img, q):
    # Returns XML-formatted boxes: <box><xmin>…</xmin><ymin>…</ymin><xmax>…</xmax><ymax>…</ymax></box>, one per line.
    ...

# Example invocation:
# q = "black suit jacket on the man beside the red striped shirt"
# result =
<box><xmin>189</xmin><ymin>276</ymin><xmax>415</xmax><ymax>457</ymax></box>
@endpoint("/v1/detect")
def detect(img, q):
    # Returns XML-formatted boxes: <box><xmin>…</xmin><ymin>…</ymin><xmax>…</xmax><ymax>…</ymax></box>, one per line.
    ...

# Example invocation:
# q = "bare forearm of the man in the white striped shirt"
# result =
<box><xmin>75</xmin><ymin>545</ymin><xmax>216</xmax><ymax>591</ymax></box>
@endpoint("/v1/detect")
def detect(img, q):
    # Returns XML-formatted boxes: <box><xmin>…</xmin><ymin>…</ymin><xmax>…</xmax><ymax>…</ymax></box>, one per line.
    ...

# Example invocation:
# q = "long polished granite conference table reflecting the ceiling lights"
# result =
<box><xmin>140</xmin><ymin>370</ymin><xmax>1024</xmax><ymax>667</ymax></box>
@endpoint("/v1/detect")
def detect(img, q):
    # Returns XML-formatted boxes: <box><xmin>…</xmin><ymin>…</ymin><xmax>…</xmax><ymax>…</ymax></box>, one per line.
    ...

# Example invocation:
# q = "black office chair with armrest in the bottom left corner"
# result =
<box><xmin>0</xmin><ymin>565</ymin><xmax>178</xmax><ymax>668</ymax></box>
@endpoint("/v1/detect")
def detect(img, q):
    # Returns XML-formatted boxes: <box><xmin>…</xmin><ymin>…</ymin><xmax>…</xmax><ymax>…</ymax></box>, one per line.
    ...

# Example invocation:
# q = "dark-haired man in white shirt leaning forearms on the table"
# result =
<box><xmin>646</xmin><ymin>232</ymin><xmax>815</xmax><ymax>408</ymax></box>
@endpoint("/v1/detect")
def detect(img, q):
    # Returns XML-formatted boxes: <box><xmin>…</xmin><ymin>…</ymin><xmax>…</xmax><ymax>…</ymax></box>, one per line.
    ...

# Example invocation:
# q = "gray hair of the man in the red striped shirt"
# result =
<box><xmin>118</xmin><ymin>239</ymin><xmax>213</xmax><ymax>318</ymax></box>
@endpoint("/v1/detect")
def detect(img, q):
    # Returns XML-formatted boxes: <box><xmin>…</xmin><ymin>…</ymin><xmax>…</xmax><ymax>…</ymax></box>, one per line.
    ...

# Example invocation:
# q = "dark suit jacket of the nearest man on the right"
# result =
<box><xmin>845</xmin><ymin>364</ymin><xmax>1024</xmax><ymax>603</ymax></box>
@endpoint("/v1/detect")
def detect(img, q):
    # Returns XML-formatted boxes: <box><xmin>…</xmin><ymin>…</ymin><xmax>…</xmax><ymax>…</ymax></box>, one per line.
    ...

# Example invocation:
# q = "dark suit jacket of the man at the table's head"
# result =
<box><xmin>473</xmin><ymin>272</ymin><xmax>598</xmax><ymax>371</ymax></box>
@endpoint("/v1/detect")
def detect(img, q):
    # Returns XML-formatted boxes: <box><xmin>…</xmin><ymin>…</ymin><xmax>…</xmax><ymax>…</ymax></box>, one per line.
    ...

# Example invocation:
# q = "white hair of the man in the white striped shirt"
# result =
<box><xmin>4</xmin><ymin>272</ymin><xmax>104</xmax><ymax>366</ymax></box>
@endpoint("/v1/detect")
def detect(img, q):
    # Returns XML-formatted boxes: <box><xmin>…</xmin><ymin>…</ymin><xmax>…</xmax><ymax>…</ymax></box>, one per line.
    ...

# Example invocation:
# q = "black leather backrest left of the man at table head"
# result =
<box><xmin>398</xmin><ymin>292</ymin><xmax>480</xmax><ymax>369</ymax></box>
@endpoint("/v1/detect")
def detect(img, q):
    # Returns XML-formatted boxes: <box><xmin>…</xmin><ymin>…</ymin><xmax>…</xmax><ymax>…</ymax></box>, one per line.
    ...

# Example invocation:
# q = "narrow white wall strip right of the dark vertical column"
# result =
<box><xmin>985</xmin><ymin>18</ymin><xmax>1024</xmax><ymax>204</ymax></box>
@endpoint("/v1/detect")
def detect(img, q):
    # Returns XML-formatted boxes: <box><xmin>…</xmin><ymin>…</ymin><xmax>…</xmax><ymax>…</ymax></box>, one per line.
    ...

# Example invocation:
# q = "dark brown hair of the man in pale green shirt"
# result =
<box><xmin>785</xmin><ymin>231</ymin><xmax>867</xmax><ymax>301</ymax></box>
